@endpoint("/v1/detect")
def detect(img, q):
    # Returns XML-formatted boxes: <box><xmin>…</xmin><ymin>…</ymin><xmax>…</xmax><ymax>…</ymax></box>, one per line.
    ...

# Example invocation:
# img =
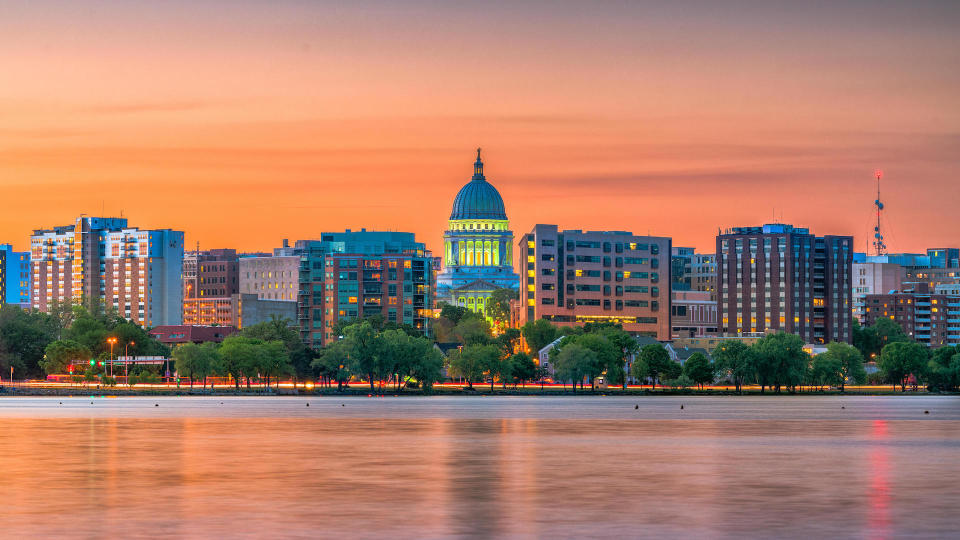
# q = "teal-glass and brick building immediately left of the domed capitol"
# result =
<box><xmin>296</xmin><ymin>229</ymin><xmax>434</xmax><ymax>347</ymax></box>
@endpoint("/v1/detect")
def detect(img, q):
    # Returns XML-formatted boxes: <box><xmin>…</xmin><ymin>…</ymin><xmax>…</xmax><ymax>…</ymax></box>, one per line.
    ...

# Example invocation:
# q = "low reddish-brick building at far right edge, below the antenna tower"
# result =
<box><xmin>864</xmin><ymin>284</ymin><xmax>960</xmax><ymax>347</ymax></box>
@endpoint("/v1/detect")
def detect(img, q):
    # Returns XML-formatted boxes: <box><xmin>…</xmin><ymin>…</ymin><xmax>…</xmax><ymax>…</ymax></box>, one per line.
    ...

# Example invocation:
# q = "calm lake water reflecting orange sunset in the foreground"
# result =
<box><xmin>0</xmin><ymin>396</ymin><xmax>960</xmax><ymax>539</ymax></box>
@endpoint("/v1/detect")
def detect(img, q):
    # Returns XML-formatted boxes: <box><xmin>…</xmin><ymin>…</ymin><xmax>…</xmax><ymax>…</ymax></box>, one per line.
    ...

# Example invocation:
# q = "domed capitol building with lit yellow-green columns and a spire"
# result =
<box><xmin>437</xmin><ymin>148</ymin><xmax>520</xmax><ymax>313</ymax></box>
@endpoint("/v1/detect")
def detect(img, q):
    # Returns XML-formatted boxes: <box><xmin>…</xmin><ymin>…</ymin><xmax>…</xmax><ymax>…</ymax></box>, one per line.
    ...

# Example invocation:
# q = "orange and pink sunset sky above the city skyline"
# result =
<box><xmin>0</xmin><ymin>0</ymin><xmax>960</xmax><ymax>254</ymax></box>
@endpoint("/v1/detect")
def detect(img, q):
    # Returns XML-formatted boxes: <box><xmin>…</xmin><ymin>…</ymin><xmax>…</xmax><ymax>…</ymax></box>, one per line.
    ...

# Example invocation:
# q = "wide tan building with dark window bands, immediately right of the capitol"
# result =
<box><xmin>519</xmin><ymin>225</ymin><xmax>671</xmax><ymax>340</ymax></box>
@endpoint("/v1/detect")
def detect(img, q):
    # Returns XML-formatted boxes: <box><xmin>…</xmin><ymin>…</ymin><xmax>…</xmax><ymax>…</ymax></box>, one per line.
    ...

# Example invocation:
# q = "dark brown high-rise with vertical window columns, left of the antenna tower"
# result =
<box><xmin>717</xmin><ymin>224</ymin><xmax>853</xmax><ymax>343</ymax></box>
